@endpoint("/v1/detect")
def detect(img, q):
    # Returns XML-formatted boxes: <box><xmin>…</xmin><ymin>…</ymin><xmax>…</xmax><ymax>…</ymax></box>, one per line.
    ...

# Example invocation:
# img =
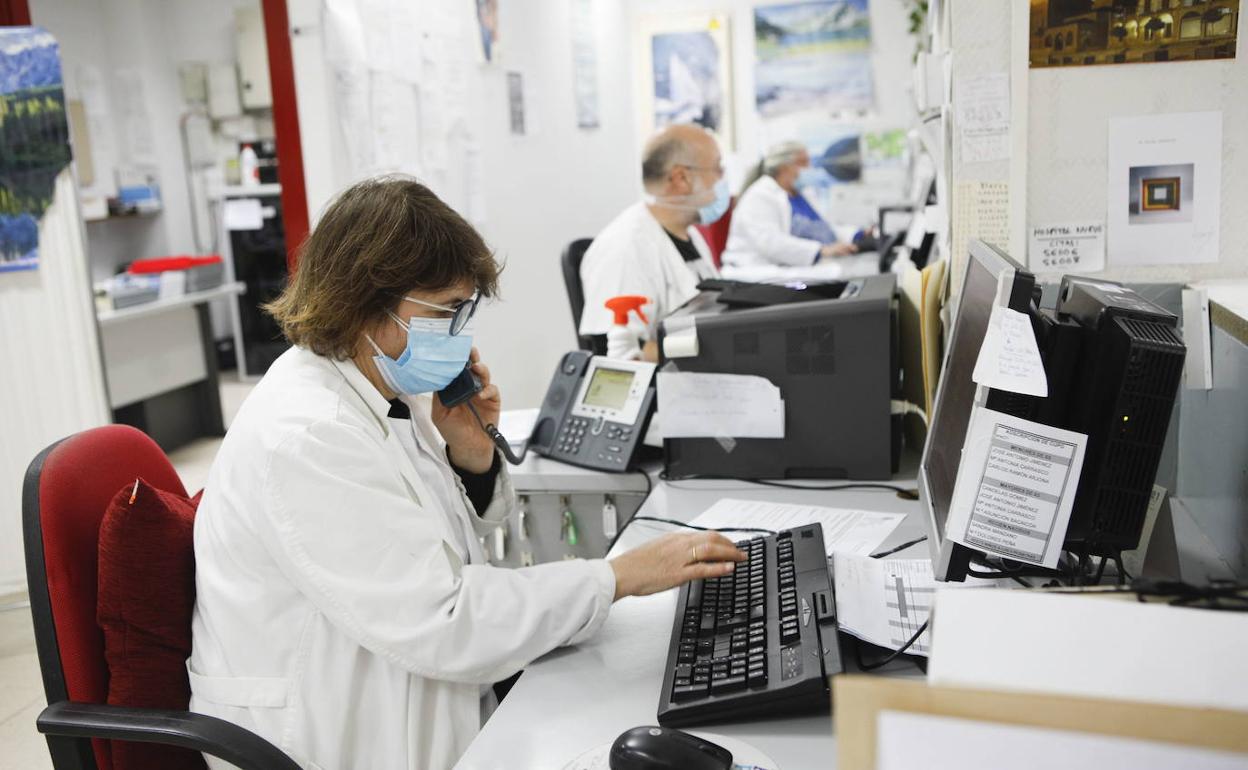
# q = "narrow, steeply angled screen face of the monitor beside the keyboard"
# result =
<box><xmin>919</xmin><ymin>242</ymin><xmax>1016</xmax><ymax>578</ymax></box>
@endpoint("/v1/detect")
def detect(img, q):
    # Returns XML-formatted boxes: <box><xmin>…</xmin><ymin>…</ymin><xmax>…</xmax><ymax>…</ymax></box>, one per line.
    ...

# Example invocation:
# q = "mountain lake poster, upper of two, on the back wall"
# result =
<box><xmin>754</xmin><ymin>0</ymin><xmax>875</xmax><ymax>117</ymax></box>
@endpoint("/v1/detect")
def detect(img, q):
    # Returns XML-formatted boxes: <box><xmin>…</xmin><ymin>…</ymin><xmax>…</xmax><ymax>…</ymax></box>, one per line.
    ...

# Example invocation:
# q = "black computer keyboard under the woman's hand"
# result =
<box><xmin>659</xmin><ymin>524</ymin><xmax>842</xmax><ymax>725</ymax></box>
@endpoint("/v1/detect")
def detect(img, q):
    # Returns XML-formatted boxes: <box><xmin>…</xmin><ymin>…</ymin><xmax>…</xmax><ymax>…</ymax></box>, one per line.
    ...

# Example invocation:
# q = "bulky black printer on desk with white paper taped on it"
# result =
<box><xmin>659</xmin><ymin>275</ymin><xmax>901</xmax><ymax>480</ymax></box>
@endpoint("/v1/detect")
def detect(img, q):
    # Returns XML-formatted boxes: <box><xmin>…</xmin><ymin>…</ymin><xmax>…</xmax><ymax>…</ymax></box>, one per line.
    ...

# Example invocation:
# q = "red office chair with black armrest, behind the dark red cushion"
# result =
<box><xmin>21</xmin><ymin>426</ymin><xmax>298</xmax><ymax>770</ymax></box>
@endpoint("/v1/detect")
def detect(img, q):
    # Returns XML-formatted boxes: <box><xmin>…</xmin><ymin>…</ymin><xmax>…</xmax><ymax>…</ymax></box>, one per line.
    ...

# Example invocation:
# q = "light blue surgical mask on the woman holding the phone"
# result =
<box><xmin>367</xmin><ymin>313</ymin><xmax>472</xmax><ymax>396</ymax></box>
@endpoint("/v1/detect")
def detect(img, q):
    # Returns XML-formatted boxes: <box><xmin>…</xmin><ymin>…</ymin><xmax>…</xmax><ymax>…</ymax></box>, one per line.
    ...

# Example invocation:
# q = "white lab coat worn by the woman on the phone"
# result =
<box><xmin>187</xmin><ymin>348</ymin><xmax>615</xmax><ymax>770</ymax></box>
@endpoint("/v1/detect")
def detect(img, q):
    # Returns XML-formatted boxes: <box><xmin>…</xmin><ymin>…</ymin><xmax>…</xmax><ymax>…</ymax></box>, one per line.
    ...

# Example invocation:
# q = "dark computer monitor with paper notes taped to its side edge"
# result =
<box><xmin>919</xmin><ymin>241</ymin><xmax>1036</xmax><ymax>579</ymax></box>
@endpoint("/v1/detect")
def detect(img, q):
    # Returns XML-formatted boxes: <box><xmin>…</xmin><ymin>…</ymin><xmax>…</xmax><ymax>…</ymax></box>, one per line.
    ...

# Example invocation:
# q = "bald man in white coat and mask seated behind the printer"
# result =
<box><xmin>580</xmin><ymin>125</ymin><xmax>730</xmax><ymax>361</ymax></box>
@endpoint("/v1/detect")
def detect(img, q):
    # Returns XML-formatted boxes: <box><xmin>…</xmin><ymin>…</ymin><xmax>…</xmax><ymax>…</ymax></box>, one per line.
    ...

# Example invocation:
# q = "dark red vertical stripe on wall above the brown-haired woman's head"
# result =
<box><xmin>260</xmin><ymin>0</ymin><xmax>308</xmax><ymax>272</ymax></box>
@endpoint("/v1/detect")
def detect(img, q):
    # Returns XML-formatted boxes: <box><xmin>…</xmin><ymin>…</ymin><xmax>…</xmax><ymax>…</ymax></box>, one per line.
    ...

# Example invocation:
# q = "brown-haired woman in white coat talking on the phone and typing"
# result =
<box><xmin>187</xmin><ymin>177</ymin><xmax>741</xmax><ymax>770</ymax></box>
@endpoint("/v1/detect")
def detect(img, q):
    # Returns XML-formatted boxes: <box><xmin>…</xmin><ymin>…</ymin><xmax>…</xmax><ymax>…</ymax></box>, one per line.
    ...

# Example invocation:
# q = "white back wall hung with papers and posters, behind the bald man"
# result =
<box><xmin>290</xmin><ymin>0</ymin><xmax>914</xmax><ymax>407</ymax></box>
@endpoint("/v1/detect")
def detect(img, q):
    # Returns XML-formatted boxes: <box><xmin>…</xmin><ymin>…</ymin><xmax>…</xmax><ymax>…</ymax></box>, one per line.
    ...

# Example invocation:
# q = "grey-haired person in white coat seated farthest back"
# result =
<box><xmin>723</xmin><ymin>142</ymin><xmax>857</xmax><ymax>270</ymax></box>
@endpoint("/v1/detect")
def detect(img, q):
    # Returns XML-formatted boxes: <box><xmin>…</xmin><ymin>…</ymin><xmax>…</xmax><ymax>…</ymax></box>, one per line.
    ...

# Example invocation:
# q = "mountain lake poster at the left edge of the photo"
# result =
<box><xmin>0</xmin><ymin>26</ymin><xmax>70</xmax><ymax>272</ymax></box>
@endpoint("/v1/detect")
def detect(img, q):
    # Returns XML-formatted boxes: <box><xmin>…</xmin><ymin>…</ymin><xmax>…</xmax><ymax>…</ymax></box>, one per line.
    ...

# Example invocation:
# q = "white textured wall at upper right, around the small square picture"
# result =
<box><xmin>950</xmin><ymin>0</ymin><xmax>1248</xmax><ymax>282</ymax></box>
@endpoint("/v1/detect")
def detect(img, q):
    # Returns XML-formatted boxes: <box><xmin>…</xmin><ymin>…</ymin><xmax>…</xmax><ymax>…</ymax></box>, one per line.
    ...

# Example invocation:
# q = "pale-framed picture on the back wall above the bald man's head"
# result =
<box><xmin>634</xmin><ymin>14</ymin><xmax>735</xmax><ymax>150</ymax></box>
